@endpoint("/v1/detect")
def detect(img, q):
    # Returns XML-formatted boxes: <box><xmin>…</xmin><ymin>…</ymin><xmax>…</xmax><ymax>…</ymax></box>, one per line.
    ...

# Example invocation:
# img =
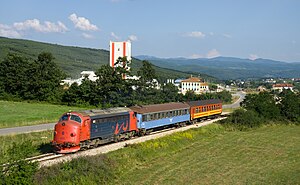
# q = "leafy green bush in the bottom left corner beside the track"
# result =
<box><xmin>0</xmin><ymin>141</ymin><xmax>38</xmax><ymax>185</ymax></box>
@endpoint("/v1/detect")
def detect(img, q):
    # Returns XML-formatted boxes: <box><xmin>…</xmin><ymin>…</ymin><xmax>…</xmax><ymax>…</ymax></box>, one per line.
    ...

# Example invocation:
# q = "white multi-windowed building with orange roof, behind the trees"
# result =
<box><xmin>181</xmin><ymin>77</ymin><xmax>209</xmax><ymax>94</ymax></box>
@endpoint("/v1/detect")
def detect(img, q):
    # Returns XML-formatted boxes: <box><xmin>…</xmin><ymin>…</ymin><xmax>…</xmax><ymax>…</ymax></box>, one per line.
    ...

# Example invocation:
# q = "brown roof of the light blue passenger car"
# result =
<box><xmin>130</xmin><ymin>102</ymin><xmax>190</xmax><ymax>114</ymax></box>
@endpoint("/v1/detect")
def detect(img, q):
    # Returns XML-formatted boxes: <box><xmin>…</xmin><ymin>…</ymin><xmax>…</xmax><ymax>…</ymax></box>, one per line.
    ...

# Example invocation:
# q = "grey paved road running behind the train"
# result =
<box><xmin>0</xmin><ymin>92</ymin><xmax>246</xmax><ymax>136</ymax></box>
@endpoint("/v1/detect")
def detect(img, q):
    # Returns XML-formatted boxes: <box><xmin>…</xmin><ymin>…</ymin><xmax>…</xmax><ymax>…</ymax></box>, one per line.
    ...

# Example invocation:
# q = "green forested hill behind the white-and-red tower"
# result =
<box><xmin>0</xmin><ymin>37</ymin><xmax>215</xmax><ymax>80</ymax></box>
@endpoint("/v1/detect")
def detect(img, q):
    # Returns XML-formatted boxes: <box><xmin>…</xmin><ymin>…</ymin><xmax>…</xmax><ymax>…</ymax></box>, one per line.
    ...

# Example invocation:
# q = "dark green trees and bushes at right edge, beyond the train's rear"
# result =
<box><xmin>221</xmin><ymin>90</ymin><xmax>300</xmax><ymax>130</ymax></box>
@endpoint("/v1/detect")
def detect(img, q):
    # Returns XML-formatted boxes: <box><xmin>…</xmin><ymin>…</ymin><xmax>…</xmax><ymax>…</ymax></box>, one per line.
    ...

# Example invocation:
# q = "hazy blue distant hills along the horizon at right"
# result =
<box><xmin>137</xmin><ymin>56</ymin><xmax>300</xmax><ymax>80</ymax></box>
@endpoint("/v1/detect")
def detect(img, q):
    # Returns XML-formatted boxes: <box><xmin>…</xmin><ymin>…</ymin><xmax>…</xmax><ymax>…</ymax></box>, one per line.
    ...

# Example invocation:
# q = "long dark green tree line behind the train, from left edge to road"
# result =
<box><xmin>0</xmin><ymin>52</ymin><xmax>232</xmax><ymax>108</ymax></box>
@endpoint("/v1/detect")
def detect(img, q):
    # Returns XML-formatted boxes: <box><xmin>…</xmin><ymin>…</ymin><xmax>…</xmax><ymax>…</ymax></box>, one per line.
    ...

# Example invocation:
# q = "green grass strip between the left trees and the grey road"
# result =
<box><xmin>0</xmin><ymin>101</ymin><xmax>84</xmax><ymax>128</ymax></box>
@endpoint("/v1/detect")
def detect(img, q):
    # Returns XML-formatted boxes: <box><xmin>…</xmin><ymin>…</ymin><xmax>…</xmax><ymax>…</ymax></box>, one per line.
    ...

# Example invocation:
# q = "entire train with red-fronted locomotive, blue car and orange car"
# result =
<box><xmin>52</xmin><ymin>99</ymin><xmax>222</xmax><ymax>153</ymax></box>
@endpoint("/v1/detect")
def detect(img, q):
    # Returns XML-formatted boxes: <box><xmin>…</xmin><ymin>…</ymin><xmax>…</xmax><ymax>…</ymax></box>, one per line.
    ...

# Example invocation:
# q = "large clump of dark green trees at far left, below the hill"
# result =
<box><xmin>0</xmin><ymin>53</ymin><xmax>65</xmax><ymax>102</ymax></box>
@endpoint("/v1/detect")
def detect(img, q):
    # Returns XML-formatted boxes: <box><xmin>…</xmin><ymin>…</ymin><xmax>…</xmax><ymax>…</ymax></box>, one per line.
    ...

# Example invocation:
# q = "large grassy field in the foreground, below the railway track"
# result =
<box><xmin>35</xmin><ymin>124</ymin><xmax>300</xmax><ymax>184</ymax></box>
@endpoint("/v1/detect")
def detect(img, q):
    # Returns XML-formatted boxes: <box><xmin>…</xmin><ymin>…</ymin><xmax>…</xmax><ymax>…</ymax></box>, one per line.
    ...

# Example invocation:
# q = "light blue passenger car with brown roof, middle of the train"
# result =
<box><xmin>130</xmin><ymin>102</ymin><xmax>190</xmax><ymax>130</ymax></box>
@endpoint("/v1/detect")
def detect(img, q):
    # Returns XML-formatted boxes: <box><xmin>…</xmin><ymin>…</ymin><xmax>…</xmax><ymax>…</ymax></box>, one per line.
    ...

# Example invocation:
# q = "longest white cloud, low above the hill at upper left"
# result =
<box><xmin>13</xmin><ymin>19</ymin><xmax>68</xmax><ymax>33</ymax></box>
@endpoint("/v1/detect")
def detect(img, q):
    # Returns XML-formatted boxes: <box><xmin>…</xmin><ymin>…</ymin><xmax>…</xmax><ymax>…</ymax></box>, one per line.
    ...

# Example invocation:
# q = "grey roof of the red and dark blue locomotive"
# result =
<box><xmin>79</xmin><ymin>107</ymin><xmax>131</xmax><ymax>117</ymax></box>
